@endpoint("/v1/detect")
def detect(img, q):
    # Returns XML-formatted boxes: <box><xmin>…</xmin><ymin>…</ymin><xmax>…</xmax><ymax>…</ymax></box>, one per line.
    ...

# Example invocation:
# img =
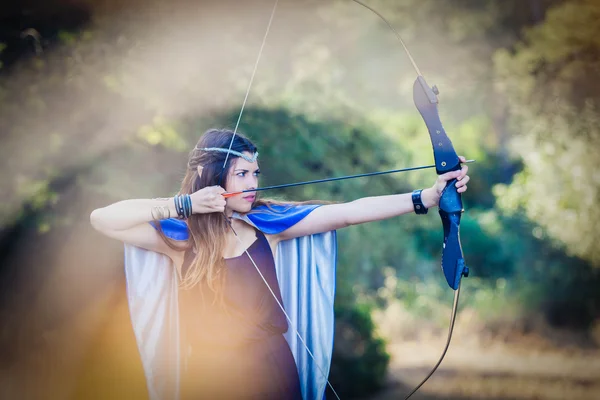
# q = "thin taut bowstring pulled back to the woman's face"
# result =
<box><xmin>219</xmin><ymin>0</ymin><xmax>341</xmax><ymax>400</ymax></box>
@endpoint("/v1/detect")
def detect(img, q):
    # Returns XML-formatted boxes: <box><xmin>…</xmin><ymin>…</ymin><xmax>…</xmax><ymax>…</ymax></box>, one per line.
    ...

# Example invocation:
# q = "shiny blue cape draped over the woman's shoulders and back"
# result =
<box><xmin>125</xmin><ymin>205</ymin><xmax>337</xmax><ymax>400</ymax></box>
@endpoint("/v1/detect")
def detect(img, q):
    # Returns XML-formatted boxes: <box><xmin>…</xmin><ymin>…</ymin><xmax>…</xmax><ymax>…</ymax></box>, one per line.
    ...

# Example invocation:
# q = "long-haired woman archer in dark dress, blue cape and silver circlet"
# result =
<box><xmin>90</xmin><ymin>130</ymin><xmax>469</xmax><ymax>399</ymax></box>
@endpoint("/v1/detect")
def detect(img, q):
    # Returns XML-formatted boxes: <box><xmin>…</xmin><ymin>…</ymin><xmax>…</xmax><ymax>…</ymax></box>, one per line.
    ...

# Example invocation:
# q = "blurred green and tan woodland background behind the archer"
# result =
<box><xmin>0</xmin><ymin>0</ymin><xmax>600</xmax><ymax>400</ymax></box>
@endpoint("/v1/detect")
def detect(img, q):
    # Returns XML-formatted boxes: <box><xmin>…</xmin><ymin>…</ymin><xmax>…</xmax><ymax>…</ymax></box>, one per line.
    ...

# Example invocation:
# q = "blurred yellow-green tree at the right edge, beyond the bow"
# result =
<box><xmin>495</xmin><ymin>0</ymin><xmax>600</xmax><ymax>266</ymax></box>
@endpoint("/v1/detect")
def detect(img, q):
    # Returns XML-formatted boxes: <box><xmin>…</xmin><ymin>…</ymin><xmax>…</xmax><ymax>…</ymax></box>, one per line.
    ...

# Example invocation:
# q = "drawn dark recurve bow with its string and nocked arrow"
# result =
<box><xmin>221</xmin><ymin>0</ymin><xmax>469</xmax><ymax>400</ymax></box>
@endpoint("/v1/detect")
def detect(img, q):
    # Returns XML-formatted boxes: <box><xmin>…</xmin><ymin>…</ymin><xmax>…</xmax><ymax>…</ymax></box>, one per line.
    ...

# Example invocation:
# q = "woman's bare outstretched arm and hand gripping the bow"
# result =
<box><xmin>278</xmin><ymin>157</ymin><xmax>469</xmax><ymax>240</ymax></box>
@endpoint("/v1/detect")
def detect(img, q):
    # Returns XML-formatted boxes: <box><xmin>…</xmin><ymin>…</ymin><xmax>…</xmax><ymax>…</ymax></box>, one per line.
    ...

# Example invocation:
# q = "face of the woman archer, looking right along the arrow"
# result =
<box><xmin>224</xmin><ymin>152</ymin><xmax>260</xmax><ymax>213</ymax></box>
